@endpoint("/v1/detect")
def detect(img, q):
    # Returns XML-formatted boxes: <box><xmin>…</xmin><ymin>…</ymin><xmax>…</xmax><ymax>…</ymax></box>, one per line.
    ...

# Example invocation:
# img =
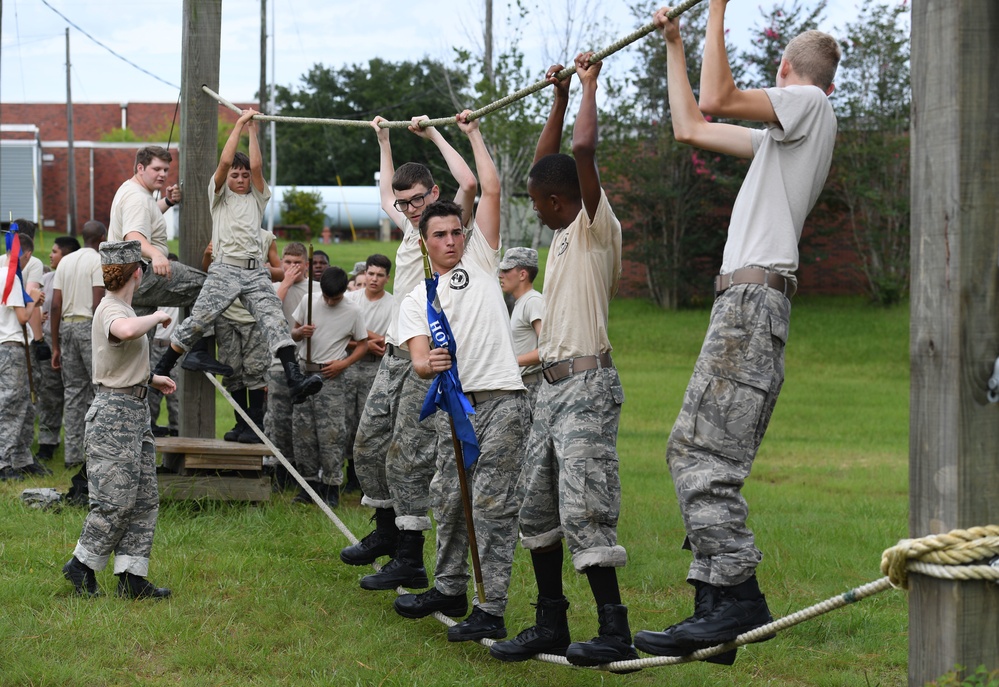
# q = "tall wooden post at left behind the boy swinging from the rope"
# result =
<box><xmin>179</xmin><ymin>0</ymin><xmax>222</xmax><ymax>438</ymax></box>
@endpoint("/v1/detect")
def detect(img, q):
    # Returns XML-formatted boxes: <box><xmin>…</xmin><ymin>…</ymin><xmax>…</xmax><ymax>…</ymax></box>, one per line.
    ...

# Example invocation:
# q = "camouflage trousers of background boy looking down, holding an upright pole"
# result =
<box><xmin>293</xmin><ymin>374</ymin><xmax>346</xmax><ymax>486</ymax></box>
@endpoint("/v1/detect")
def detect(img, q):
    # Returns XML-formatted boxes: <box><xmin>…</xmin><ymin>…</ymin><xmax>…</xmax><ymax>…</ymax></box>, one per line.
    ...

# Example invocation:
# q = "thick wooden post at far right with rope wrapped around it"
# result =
<box><xmin>909</xmin><ymin>0</ymin><xmax>999</xmax><ymax>687</ymax></box>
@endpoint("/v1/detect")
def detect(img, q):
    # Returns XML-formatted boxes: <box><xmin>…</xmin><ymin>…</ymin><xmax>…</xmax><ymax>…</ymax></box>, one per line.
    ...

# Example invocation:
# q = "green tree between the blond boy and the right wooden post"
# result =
<box><xmin>830</xmin><ymin>0</ymin><xmax>910</xmax><ymax>305</ymax></box>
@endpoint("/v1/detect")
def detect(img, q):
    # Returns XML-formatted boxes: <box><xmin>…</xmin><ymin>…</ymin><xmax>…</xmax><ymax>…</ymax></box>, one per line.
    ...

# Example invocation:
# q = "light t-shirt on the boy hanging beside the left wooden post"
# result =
<box><xmin>208</xmin><ymin>174</ymin><xmax>271</xmax><ymax>260</ymax></box>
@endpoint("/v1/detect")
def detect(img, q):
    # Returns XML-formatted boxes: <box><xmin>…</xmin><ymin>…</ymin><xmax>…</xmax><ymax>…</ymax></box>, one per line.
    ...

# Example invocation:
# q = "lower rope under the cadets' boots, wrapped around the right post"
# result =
<box><xmin>205</xmin><ymin>372</ymin><xmax>999</xmax><ymax>673</ymax></box>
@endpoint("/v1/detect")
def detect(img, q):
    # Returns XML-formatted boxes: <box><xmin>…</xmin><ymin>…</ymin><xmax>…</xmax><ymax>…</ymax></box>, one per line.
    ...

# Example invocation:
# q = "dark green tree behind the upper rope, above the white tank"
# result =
<box><xmin>275</xmin><ymin>58</ymin><xmax>470</xmax><ymax>190</ymax></box>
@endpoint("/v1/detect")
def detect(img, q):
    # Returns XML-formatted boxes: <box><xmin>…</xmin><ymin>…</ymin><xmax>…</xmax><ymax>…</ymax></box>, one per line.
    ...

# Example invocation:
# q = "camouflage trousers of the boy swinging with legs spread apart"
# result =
<box><xmin>170</xmin><ymin>262</ymin><xmax>295</xmax><ymax>355</ymax></box>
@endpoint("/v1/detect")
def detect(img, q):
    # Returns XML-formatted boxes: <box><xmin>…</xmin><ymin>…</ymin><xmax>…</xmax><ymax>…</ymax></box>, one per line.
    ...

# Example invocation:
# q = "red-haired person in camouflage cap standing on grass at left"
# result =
<box><xmin>62</xmin><ymin>241</ymin><xmax>177</xmax><ymax>599</ymax></box>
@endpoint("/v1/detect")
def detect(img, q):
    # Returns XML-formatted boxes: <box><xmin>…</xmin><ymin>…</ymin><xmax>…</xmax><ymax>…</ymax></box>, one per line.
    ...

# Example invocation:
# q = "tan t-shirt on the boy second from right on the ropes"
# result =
<box><xmin>538</xmin><ymin>191</ymin><xmax>621</xmax><ymax>363</ymax></box>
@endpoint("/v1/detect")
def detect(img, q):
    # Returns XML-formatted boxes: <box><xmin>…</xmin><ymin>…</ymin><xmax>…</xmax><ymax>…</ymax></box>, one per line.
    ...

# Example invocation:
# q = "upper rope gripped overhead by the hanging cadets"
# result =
<box><xmin>201</xmin><ymin>0</ymin><xmax>701</xmax><ymax>129</ymax></box>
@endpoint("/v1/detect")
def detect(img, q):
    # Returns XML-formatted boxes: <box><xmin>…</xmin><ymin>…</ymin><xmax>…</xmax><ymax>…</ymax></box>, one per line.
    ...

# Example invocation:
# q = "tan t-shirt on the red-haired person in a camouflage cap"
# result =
<box><xmin>91</xmin><ymin>296</ymin><xmax>149</xmax><ymax>389</ymax></box>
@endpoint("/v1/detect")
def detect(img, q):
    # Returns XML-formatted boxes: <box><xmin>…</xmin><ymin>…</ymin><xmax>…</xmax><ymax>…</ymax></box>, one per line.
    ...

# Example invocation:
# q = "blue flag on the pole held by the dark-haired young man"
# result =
<box><xmin>420</xmin><ymin>274</ymin><xmax>479</xmax><ymax>468</ymax></box>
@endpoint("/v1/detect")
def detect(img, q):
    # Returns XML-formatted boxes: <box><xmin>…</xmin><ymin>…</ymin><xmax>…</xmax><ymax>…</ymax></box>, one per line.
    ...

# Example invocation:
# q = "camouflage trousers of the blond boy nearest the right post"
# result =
<box><xmin>666</xmin><ymin>285</ymin><xmax>791</xmax><ymax>586</ymax></box>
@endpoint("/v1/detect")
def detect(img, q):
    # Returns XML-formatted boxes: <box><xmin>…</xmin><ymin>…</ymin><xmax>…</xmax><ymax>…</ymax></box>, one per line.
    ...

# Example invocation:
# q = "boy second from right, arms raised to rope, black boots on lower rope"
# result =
<box><xmin>490</xmin><ymin>53</ymin><xmax>638</xmax><ymax>666</ymax></box>
